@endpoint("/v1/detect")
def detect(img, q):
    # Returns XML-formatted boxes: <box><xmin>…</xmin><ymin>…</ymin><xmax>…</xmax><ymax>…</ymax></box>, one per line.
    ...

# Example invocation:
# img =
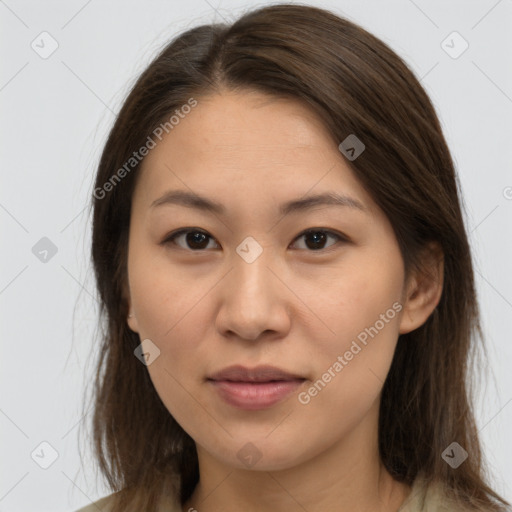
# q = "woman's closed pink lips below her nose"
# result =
<box><xmin>207</xmin><ymin>366</ymin><xmax>306</xmax><ymax>411</ymax></box>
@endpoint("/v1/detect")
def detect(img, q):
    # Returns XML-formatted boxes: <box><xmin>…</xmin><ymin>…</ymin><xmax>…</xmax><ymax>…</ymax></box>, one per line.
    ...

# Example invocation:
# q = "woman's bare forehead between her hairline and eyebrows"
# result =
<box><xmin>131</xmin><ymin>92</ymin><xmax>369</xmax><ymax>213</ymax></box>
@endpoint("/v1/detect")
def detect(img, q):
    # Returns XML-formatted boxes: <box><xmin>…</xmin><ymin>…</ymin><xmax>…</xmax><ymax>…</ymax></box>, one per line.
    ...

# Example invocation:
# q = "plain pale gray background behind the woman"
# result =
<box><xmin>0</xmin><ymin>0</ymin><xmax>512</xmax><ymax>512</ymax></box>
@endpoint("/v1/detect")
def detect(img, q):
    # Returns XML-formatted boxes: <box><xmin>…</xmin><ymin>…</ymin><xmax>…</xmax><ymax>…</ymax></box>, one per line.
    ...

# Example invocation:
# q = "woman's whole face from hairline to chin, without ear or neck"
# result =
<box><xmin>128</xmin><ymin>92</ymin><xmax>407</xmax><ymax>470</ymax></box>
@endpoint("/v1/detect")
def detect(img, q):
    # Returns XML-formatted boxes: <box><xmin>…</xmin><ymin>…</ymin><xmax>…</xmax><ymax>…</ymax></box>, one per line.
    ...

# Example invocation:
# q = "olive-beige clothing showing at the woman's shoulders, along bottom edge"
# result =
<box><xmin>75</xmin><ymin>479</ymin><xmax>465</xmax><ymax>512</ymax></box>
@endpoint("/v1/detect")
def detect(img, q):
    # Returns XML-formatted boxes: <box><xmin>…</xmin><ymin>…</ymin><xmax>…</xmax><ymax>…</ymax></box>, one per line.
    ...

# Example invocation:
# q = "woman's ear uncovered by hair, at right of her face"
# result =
<box><xmin>399</xmin><ymin>242</ymin><xmax>444</xmax><ymax>334</ymax></box>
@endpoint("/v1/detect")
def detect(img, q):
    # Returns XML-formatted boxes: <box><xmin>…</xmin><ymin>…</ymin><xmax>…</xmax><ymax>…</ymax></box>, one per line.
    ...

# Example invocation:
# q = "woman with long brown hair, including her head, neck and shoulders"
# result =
<box><xmin>75</xmin><ymin>5</ymin><xmax>506</xmax><ymax>512</ymax></box>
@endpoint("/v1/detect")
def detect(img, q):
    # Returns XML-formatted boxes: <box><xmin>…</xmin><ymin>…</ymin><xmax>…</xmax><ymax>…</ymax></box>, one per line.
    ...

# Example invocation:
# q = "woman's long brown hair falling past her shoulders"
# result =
<box><xmin>84</xmin><ymin>4</ymin><xmax>506</xmax><ymax>512</ymax></box>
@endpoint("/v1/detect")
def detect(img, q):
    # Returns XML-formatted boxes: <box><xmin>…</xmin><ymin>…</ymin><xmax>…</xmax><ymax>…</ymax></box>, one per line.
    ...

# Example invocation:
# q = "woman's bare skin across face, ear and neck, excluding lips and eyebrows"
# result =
<box><xmin>127</xmin><ymin>90</ymin><xmax>442</xmax><ymax>512</ymax></box>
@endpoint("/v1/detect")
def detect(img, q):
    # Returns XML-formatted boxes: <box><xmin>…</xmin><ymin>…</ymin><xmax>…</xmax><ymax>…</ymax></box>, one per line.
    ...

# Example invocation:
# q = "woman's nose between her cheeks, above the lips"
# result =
<box><xmin>216</xmin><ymin>246</ymin><xmax>293</xmax><ymax>341</ymax></box>
